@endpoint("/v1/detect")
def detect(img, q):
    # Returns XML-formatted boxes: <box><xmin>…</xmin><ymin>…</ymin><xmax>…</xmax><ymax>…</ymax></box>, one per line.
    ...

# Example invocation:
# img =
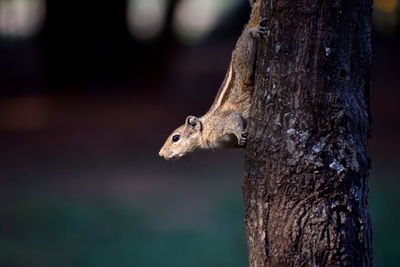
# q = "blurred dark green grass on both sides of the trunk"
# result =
<box><xmin>0</xmin><ymin>160</ymin><xmax>400</xmax><ymax>267</ymax></box>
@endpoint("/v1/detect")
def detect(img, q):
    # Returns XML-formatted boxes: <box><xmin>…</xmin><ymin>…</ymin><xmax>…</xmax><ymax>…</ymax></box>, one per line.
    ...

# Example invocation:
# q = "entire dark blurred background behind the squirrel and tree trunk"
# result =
<box><xmin>0</xmin><ymin>0</ymin><xmax>400</xmax><ymax>267</ymax></box>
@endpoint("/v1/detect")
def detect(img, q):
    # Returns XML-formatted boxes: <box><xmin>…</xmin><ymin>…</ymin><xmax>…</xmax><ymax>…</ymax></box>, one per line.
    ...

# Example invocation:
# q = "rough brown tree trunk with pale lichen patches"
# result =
<box><xmin>242</xmin><ymin>0</ymin><xmax>372</xmax><ymax>266</ymax></box>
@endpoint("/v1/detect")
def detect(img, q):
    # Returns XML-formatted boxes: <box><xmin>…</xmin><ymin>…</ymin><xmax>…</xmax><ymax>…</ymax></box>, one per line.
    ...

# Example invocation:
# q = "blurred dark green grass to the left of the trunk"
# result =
<box><xmin>0</xmin><ymin>198</ymin><xmax>246</xmax><ymax>267</ymax></box>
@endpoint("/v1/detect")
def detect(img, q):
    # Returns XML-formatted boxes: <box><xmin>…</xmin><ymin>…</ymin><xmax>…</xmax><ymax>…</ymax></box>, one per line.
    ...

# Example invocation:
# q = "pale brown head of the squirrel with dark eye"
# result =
<box><xmin>158</xmin><ymin>116</ymin><xmax>203</xmax><ymax>159</ymax></box>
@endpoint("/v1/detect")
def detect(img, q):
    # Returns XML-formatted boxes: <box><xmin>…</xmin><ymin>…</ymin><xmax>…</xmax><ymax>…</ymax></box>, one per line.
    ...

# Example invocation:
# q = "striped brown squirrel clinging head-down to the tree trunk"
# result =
<box><xmin>159</xmin><ymin>0</ymin><xmax>266</xmax><ymax>159</ymax></box>
